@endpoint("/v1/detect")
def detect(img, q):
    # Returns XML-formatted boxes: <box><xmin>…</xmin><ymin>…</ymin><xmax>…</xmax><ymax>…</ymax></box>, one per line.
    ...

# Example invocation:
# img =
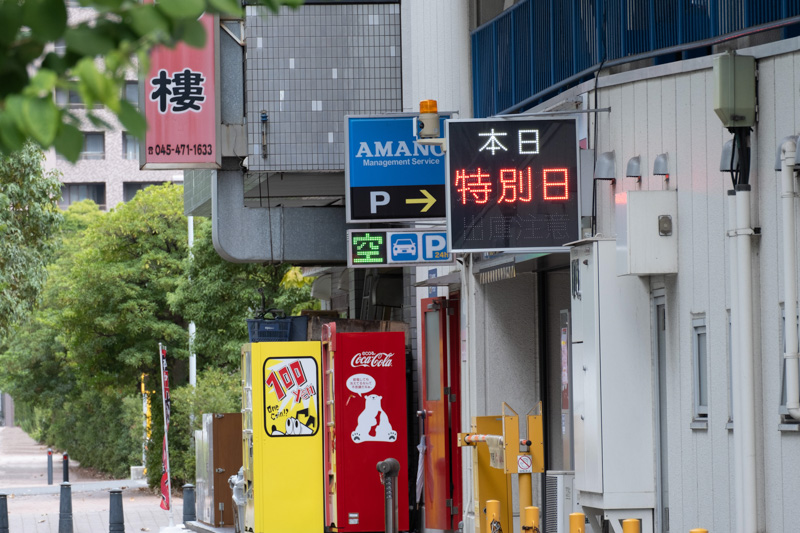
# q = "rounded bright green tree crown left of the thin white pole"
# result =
<box><xmin>60</xmin><ymin>184</ymin><xmax>188</xmax><ymax>386</ymax></box>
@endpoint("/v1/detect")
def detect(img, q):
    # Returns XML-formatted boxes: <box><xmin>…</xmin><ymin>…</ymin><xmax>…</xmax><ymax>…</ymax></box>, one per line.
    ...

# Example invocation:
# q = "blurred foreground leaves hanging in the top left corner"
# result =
<box><xmin>0</xmin><ymin>0</ymin><xmax>302</xmax><ymax>161</ymax></box>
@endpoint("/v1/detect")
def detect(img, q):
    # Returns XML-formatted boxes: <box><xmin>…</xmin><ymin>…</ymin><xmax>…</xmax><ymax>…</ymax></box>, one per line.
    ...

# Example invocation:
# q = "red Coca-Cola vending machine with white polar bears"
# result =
<box><xmin>322</xmin><ymin>323</ymin><xmax>409</xmax><ymax>533</ymax></box>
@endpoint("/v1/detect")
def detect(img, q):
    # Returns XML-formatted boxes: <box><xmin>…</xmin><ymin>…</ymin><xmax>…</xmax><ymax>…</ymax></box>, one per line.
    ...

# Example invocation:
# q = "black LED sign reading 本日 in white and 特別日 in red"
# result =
<box><xmin>446</xmin><ymin>117</ymin><xmax>580</xmax><ymax>252</ymax></box>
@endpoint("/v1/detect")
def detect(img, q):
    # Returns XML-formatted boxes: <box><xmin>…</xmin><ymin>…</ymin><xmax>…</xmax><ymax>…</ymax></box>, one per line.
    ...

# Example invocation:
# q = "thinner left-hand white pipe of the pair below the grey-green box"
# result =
<box><xmin>728</xmin><ymin>189</ymin><xmax>744</xmax><ymax>533</ymax></box>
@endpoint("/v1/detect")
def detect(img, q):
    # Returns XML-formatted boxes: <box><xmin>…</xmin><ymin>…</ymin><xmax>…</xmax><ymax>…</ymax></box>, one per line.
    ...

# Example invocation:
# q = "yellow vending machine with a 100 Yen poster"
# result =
<box><xmin>242</xmin><ymin>342</ymin><xmax>325</xmax><ymax>533</ymax></box>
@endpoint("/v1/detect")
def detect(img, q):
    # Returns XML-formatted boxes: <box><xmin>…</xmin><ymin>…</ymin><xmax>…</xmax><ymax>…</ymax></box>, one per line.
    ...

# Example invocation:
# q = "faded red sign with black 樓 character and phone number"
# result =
<box><xmin>140</xmin><ymin>15</ymin><xmax>221</xmax><ymax>169</ymax></box>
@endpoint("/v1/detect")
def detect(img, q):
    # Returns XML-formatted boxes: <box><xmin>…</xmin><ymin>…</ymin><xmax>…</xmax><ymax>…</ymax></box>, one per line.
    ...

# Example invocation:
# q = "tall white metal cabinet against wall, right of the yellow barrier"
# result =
<box><xmin>570</xmin><ymin>239</ymin><xmax>656</xmax><ymax>513</ymax></box>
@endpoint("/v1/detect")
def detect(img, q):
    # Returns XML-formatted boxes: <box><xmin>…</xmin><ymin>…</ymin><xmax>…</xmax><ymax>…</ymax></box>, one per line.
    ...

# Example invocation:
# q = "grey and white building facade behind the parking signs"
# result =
<box><xmin>186</xmin><ymin>0</ymin><xmax>800</xmax><ymax>533</ymax></box>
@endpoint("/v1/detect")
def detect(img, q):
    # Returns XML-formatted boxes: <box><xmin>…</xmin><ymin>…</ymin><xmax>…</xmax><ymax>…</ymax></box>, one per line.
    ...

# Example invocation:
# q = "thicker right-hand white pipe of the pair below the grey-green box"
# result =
<box><xmin>734</xmin><ymin>183</ymin><xmax>758</xmax><ymax>533</ymax></box>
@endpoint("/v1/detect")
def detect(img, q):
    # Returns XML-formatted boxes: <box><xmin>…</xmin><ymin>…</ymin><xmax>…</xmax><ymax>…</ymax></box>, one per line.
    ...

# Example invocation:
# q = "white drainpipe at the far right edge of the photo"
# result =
<box><xmin>781</xmin><ymin>138</ymin><xmax>800</xmax><ymax>420</ymax></box>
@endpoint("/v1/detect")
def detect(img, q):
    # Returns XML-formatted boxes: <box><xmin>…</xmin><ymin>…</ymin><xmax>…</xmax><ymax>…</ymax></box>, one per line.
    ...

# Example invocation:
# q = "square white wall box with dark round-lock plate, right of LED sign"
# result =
<box><xmin>615</xmin><ymin>191</ymin><xmax>678</xmax><ymax>276</ymax></box>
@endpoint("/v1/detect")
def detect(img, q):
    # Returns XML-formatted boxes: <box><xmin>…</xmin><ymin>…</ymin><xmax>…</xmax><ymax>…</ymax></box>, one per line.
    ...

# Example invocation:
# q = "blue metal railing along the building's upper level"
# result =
<box><xmin>471</xmin><ymin>0</ymin><xmax>800</xmax><ymax>117</ymax></box>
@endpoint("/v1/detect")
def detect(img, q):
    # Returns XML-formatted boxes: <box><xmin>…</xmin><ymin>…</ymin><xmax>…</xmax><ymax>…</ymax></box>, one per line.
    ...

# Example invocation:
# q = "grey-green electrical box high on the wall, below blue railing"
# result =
<box><xmin>714</xmin><ymin>52</ymin><xmax>756</xmax><ymax>128</ymax></box>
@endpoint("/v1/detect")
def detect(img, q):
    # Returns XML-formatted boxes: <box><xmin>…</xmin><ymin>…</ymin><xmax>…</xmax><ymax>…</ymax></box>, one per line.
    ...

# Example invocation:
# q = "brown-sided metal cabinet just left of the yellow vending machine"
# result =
<box><xmin>195</xmin><ymin>413</ymin><xmax>242</xmax><ymax>527</ymax></box>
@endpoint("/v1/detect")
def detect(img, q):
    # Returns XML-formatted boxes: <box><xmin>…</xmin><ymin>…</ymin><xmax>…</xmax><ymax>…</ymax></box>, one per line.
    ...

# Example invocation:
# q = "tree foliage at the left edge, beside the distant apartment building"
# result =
<box><xmin>0</xmin><ymin>141</ymin><xmax>61</xmax><ymax>338</ymax></box>
